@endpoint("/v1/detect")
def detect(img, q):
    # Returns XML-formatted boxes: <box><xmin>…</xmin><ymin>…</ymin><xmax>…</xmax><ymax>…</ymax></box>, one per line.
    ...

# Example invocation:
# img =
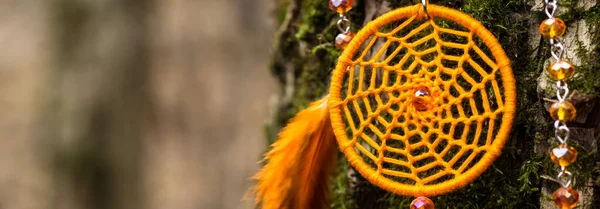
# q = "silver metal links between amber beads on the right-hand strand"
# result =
<box><xmin>544</xmin><ymin>0</ymin><xmax>574</xmax><ymax>188</ymax></box>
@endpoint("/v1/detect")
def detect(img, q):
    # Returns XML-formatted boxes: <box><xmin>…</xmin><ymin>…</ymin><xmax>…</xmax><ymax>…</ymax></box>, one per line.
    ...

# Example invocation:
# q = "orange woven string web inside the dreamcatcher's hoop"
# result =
<box><xmin>332</xmin><ymin>13</ymin><xmax>505</xmax><ymax>186</ymax></box>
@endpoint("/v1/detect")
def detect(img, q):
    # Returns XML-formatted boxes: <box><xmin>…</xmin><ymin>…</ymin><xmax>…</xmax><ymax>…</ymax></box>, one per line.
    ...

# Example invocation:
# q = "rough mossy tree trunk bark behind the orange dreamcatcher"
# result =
<box><xmin>267</xmin><ymin>0</ymin><xmax>600</xmax><ymax>209</ymax></box>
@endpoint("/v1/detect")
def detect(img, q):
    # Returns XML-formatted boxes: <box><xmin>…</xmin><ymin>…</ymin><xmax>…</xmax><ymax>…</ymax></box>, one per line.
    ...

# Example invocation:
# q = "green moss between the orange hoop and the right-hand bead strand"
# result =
<box><xmin>359</xmin><ymin>1</ymin><xmax>545</xmax><ymax>209</ymax></box>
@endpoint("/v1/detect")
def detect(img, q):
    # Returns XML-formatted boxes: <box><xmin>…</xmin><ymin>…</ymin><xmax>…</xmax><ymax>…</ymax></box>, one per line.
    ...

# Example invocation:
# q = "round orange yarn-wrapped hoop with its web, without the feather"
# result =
<box><xmin>329</xmin><ymin>5</ymin><xmax>515</xmax><ymax>196</ymax></box>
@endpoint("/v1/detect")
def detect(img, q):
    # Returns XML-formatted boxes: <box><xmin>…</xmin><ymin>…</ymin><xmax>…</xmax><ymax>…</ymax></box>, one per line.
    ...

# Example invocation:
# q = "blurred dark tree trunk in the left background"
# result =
<box><xmin>44</xmin><ymin>0</ymin><xmax>155</xmax><ymax>209</ymax></box>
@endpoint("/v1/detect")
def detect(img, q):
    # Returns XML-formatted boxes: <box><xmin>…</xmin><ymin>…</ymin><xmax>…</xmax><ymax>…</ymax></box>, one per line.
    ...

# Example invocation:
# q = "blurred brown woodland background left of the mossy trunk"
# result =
<box><xmin>0</xmin><ymin>0</ymin><xmax>279</xmax><ymax>209</ymax></box>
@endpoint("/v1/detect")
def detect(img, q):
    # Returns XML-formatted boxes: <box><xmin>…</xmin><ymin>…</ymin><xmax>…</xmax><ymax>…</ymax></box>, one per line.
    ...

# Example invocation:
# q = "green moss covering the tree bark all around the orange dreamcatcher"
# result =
<box><xmin>267</xmin><ymin>0</ymin><xmax>600</xmax><ymax>209</ymax></box>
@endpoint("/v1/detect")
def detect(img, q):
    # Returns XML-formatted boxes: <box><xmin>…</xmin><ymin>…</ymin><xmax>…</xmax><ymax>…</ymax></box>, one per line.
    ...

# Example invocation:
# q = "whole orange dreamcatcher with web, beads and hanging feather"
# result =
<box><xmin>255</xmin><ymin>0</ymin><xmax>516</xmax><ymax>209</ymax></box>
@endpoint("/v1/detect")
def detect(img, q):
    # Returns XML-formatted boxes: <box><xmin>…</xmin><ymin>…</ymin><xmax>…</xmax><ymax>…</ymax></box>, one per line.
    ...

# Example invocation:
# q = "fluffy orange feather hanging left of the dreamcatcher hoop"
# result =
<box><xmin>254</xmin><ymin>96</ymin><xmax>337</xmax><ymax>209</ymax></box>
